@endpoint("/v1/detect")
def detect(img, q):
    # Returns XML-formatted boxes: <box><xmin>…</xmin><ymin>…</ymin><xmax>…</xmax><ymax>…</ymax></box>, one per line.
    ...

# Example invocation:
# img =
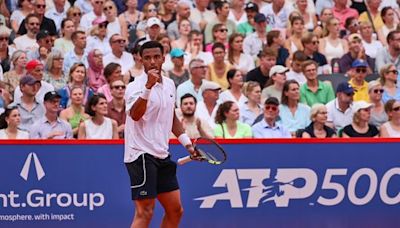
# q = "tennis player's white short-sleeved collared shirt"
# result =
<box><xmin>124</xmin><ymin>74</ymin><xmax>176</xmax><ymax>163</ymax></box>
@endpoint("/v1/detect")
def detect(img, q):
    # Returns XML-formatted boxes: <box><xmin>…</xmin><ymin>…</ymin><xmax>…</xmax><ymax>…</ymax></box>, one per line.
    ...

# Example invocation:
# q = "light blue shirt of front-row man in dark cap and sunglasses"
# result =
<box><xmin>252</xmin><ymin>118</ymin><xmax>292</xmax><ymax>138</ymax></box>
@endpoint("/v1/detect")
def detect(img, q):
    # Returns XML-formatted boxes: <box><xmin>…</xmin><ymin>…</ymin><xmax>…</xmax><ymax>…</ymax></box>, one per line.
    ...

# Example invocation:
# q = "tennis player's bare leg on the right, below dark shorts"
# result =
<box><xmin>157</xmin><ymin>189</ymin><xmax>183</xmax><ymax>228</ymax></box>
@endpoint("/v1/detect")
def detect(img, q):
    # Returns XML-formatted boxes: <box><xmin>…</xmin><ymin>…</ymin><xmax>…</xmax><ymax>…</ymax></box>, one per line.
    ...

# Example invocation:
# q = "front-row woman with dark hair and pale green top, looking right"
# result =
<box><xmin>214</xmin><ymin>101</ymin><xmax>252</xmax><ymax>139</ymax></box>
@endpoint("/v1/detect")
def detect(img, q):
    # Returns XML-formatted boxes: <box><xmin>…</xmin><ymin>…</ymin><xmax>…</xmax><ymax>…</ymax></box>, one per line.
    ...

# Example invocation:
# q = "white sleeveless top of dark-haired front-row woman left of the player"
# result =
<box><xmin>85</xmin><ymin>117</ymin><xmax>113</xmax><ymax>139</ymax></box>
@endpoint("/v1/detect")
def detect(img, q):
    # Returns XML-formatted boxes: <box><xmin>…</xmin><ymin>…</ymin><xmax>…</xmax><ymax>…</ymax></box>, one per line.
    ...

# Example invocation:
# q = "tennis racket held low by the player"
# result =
<box><xmin>178</xmin><ymin>137</ymin><xmax>226</xmax><ymax>165</ymax></box>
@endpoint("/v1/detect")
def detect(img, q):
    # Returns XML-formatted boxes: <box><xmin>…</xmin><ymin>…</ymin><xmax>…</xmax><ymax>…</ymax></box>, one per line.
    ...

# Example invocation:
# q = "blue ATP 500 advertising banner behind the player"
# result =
<box><xmin>0</xmin><ymin>141</ymin><xmax>400</xmax><ymax>227</ymax></box>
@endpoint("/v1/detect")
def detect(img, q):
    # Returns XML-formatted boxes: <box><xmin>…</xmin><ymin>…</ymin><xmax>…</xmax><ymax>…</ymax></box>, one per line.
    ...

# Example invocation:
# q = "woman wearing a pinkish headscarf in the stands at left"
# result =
<box><xmin>87</xmin><ymin>49</ymin><xmax>107</xmax><ymax>92</ymax></box>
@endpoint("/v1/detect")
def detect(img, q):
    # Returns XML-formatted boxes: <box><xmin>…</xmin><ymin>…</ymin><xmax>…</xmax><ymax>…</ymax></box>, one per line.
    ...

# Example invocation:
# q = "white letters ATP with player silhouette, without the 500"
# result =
<box><xmin>195</xmin><ymin>168</ymin><xmax>318</xmax><ymax>208</ymax></box>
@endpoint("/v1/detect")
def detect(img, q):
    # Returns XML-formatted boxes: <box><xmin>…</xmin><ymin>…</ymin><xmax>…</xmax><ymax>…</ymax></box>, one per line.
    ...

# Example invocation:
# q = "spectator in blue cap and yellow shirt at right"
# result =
<box><xmin>348</xmin><ymin>59</ymin><xmax>369</xmax><ymax>101</ymax></box>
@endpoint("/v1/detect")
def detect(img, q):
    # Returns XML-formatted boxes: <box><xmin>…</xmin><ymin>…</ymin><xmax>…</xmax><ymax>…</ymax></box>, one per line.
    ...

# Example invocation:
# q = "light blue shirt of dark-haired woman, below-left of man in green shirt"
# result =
<box><xmin>279</xmin><ymin>103</ymin><xmax>311</xmax><ymax>132</ymax></box>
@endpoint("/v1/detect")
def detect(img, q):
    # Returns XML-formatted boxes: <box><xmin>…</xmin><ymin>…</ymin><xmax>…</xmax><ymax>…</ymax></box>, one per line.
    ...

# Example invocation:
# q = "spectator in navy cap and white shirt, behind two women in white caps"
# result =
<box><xmin>326</xmin><ymin>82</ymin><xmax>354</xmax><ymax>131</ymax></box>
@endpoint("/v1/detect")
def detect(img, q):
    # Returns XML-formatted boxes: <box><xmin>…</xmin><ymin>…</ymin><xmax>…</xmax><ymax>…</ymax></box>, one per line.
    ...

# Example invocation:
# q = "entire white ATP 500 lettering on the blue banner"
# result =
<box><xmin>195</xmin><ymin>167</ymin><xmax>400</xmax><ymax>208</ymax></box>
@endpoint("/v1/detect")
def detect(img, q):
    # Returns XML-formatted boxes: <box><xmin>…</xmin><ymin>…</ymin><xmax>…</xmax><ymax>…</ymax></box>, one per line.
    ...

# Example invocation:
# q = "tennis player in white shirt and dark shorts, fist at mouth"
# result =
<box><xmin>124</xmin><ymin>41</ymin><xmax>198</xmax><ymax>228</ymax></box>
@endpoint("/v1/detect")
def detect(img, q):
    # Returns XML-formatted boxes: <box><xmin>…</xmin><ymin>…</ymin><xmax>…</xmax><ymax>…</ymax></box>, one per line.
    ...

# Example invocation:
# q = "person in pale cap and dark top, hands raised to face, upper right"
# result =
<box><xmin>339</xmin><ymin>33</ymin><xmax>375</xmax><ymax>74</ymax></box>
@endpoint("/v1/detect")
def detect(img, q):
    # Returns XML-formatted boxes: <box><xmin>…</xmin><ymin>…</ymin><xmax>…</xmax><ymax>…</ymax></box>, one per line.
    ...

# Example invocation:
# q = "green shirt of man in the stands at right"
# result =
<box><xmin>300</xmin><ymin>80</ymin><xmax>335</xmax><ymax>107</ymax></box>
